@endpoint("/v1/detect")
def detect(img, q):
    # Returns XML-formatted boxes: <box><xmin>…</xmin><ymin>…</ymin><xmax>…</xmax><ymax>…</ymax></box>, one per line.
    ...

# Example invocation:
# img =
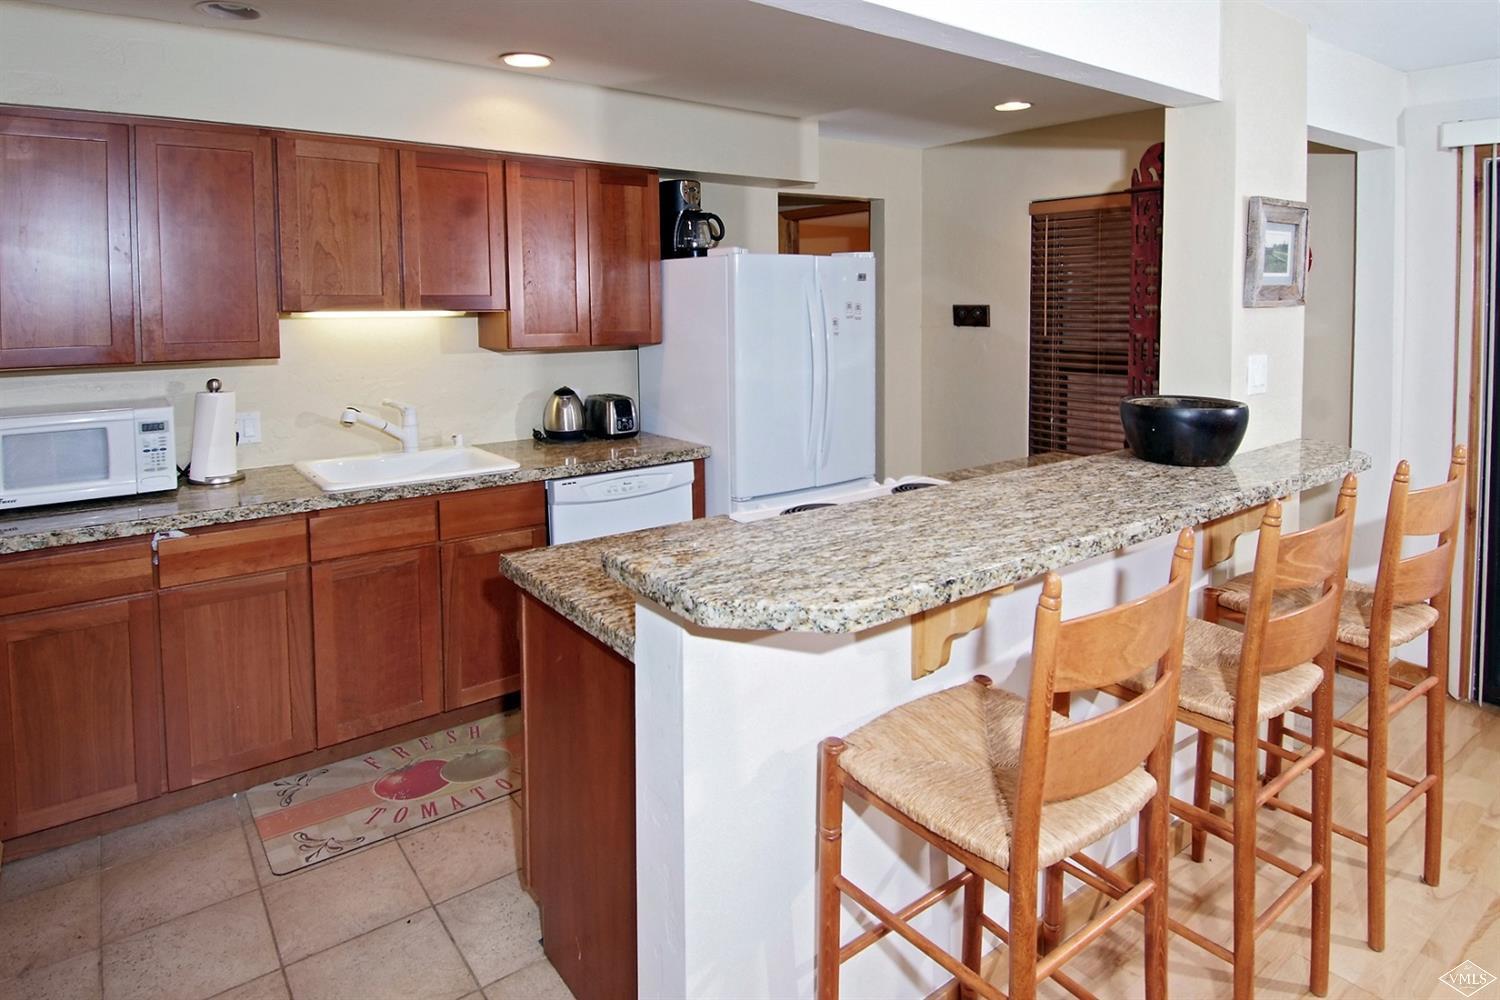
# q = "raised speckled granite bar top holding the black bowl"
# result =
<box><xmin>602</xmin><ymin>441</ymin><xmax>1370</xmax><ymax>633</ymax></box>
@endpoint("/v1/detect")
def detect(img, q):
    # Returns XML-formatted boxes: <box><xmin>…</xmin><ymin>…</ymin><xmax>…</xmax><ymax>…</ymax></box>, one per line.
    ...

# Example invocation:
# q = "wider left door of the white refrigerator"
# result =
<box><xmin>729</xmin><ymin>253</ymin><xmax>824</xmax><ymax>501</ymax></box>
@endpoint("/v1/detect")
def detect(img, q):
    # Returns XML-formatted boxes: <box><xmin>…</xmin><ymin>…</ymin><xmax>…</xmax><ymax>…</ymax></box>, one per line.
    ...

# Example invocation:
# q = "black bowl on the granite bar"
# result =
<box><xmin>1121</xmin><ymin>396</ymin><xmax>1250</xmax><ymax>466</ymax></box>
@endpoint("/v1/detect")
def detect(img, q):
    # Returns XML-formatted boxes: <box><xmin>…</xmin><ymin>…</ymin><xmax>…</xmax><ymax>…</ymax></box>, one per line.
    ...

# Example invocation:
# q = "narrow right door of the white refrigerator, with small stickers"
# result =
<box><xmin>815</xmin><ymin>256</ymin><xmax>876</xmax><ymax>486</ymax></box>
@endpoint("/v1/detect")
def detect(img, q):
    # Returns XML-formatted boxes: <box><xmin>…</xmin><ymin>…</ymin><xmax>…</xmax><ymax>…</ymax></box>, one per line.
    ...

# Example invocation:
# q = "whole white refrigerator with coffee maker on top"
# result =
<box><xmin>641</xmin><ymin>249</ymin><xmax>876</xmax><ymax>514</ymax></box>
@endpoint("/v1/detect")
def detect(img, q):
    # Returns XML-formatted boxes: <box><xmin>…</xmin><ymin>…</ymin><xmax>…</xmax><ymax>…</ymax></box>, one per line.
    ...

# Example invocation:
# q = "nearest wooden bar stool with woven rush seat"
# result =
<box><xmin>818</xmin><ymin>531</ymin><xmax>1193</xmax><ymax>1000</ymax></box>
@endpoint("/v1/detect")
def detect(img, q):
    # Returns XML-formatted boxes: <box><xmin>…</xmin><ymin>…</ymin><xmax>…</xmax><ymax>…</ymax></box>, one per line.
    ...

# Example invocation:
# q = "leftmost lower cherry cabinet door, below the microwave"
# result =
<box><xmin>0</xmin><ymin>595</ymin><xmax>162</xmax><ymax>837</ymax></box>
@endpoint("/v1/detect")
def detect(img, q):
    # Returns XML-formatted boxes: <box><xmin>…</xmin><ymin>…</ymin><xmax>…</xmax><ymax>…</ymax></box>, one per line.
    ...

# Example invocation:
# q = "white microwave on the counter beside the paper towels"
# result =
<box><xmin>0</xmin><ymin>399</ymin><xmax>177</xmax><ymax>511</ymax></box>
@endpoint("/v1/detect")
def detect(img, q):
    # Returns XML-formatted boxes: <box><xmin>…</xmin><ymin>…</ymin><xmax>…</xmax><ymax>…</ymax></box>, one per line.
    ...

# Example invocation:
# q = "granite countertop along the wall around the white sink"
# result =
<box><xmin>0</xmin><ymin>433</ymin><xmax>708</xmax><ymax>555</ymax></box>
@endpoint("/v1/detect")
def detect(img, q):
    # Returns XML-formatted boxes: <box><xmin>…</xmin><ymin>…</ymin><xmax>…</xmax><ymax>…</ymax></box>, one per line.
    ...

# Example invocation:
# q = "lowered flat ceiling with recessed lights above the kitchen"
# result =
<box><xmin>29</xmin><ymin>0</ymin><xmax>1152</xmax><ymax>147</ymax></box>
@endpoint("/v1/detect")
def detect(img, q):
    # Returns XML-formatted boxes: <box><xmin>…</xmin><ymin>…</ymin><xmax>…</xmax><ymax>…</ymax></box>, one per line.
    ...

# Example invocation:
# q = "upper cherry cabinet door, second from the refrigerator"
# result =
<box><xmin>506</xmin><ymin>160</ymin><xmax>590</xmax><ymax>348</ymax></box>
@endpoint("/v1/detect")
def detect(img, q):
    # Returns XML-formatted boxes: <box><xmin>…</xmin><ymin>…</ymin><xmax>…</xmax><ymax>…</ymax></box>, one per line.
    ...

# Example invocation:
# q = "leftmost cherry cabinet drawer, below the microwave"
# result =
<box><xmin>0</xmin><ymin>537</ymin><xmax>153</xmax><ymax>615</ymax></box>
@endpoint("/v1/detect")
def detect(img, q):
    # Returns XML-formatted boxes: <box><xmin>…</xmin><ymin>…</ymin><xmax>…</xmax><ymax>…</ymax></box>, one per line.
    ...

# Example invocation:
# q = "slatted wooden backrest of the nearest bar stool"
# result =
<box><xmin>1017</xmin><ymin>528</ymin><xmax>1193</xmax><ymax>803</ymax></box>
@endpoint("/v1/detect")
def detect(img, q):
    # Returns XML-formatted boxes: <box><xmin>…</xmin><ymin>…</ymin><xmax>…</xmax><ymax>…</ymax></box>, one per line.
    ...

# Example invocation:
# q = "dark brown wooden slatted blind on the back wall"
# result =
<box><xmin>1028</xmin><ymin>193</ymin><xmax>1133</xmax><ymax>454</ymax></box>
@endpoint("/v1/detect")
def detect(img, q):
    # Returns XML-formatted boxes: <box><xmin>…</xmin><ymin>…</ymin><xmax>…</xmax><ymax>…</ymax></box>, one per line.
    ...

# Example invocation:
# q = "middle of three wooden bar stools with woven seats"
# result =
<box><xmin>1124</xmin><ymin>475</ymin><xmax>1356</xmax><ymax>1000</ymax></box>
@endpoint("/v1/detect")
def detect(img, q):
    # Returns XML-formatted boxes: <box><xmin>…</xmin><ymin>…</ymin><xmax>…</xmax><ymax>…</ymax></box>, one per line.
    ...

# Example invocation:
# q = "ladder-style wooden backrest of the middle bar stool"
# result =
<box><xmin>1235</xmin><ymin>474</ymin><xmax>1358</xmax><ymax>695</ymax></box>
